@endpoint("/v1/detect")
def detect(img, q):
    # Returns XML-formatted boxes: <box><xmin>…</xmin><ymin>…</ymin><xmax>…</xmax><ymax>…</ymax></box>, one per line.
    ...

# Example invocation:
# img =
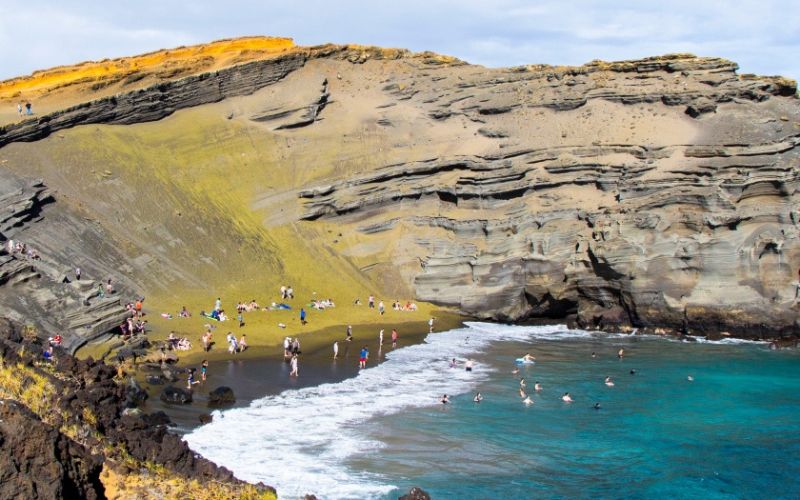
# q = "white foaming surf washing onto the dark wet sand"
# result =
<box><xmin>185</xmin><ymin>323</ymin><xmax>580</xmax><ymax>498</ymax></box>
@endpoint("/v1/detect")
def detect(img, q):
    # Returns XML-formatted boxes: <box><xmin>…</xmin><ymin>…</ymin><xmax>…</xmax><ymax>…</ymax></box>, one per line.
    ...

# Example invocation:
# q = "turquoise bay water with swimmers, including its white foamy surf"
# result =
<box><xmin>187</xmin><ymin>323</ymin><xmax>800</xmax><ymax>498</ymax></box>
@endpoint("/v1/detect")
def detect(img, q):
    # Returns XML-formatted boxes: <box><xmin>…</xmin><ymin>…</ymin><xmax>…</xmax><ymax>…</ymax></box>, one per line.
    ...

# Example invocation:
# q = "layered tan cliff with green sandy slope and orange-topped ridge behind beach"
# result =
<box><xmin>0</xmin><ymin>34</ymin><xmax>800</xmax><ymax>340</ymax></box>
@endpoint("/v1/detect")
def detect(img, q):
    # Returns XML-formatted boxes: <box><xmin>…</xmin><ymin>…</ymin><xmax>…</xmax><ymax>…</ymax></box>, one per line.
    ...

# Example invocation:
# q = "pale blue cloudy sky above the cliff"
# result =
<box><xmin>0</xmin><ymin>0</ymin><xmax>800</xmax><ymax>79</ymax></box>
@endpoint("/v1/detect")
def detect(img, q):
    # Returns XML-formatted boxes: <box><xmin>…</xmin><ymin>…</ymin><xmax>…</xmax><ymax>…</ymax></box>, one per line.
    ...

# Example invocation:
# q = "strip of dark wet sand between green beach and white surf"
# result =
<box><xmin>142</xmin><ymin>313</ymin><xmax>467</xmax><ymax>432</ymax></box>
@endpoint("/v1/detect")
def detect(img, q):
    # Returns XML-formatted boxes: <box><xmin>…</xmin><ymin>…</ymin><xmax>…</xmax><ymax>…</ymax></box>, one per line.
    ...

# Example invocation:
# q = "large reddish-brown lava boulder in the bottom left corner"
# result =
<box><xmin>0</xmin><ymin>400</ymin><xmax>105</xmax><ymax>499</ymax></box>
